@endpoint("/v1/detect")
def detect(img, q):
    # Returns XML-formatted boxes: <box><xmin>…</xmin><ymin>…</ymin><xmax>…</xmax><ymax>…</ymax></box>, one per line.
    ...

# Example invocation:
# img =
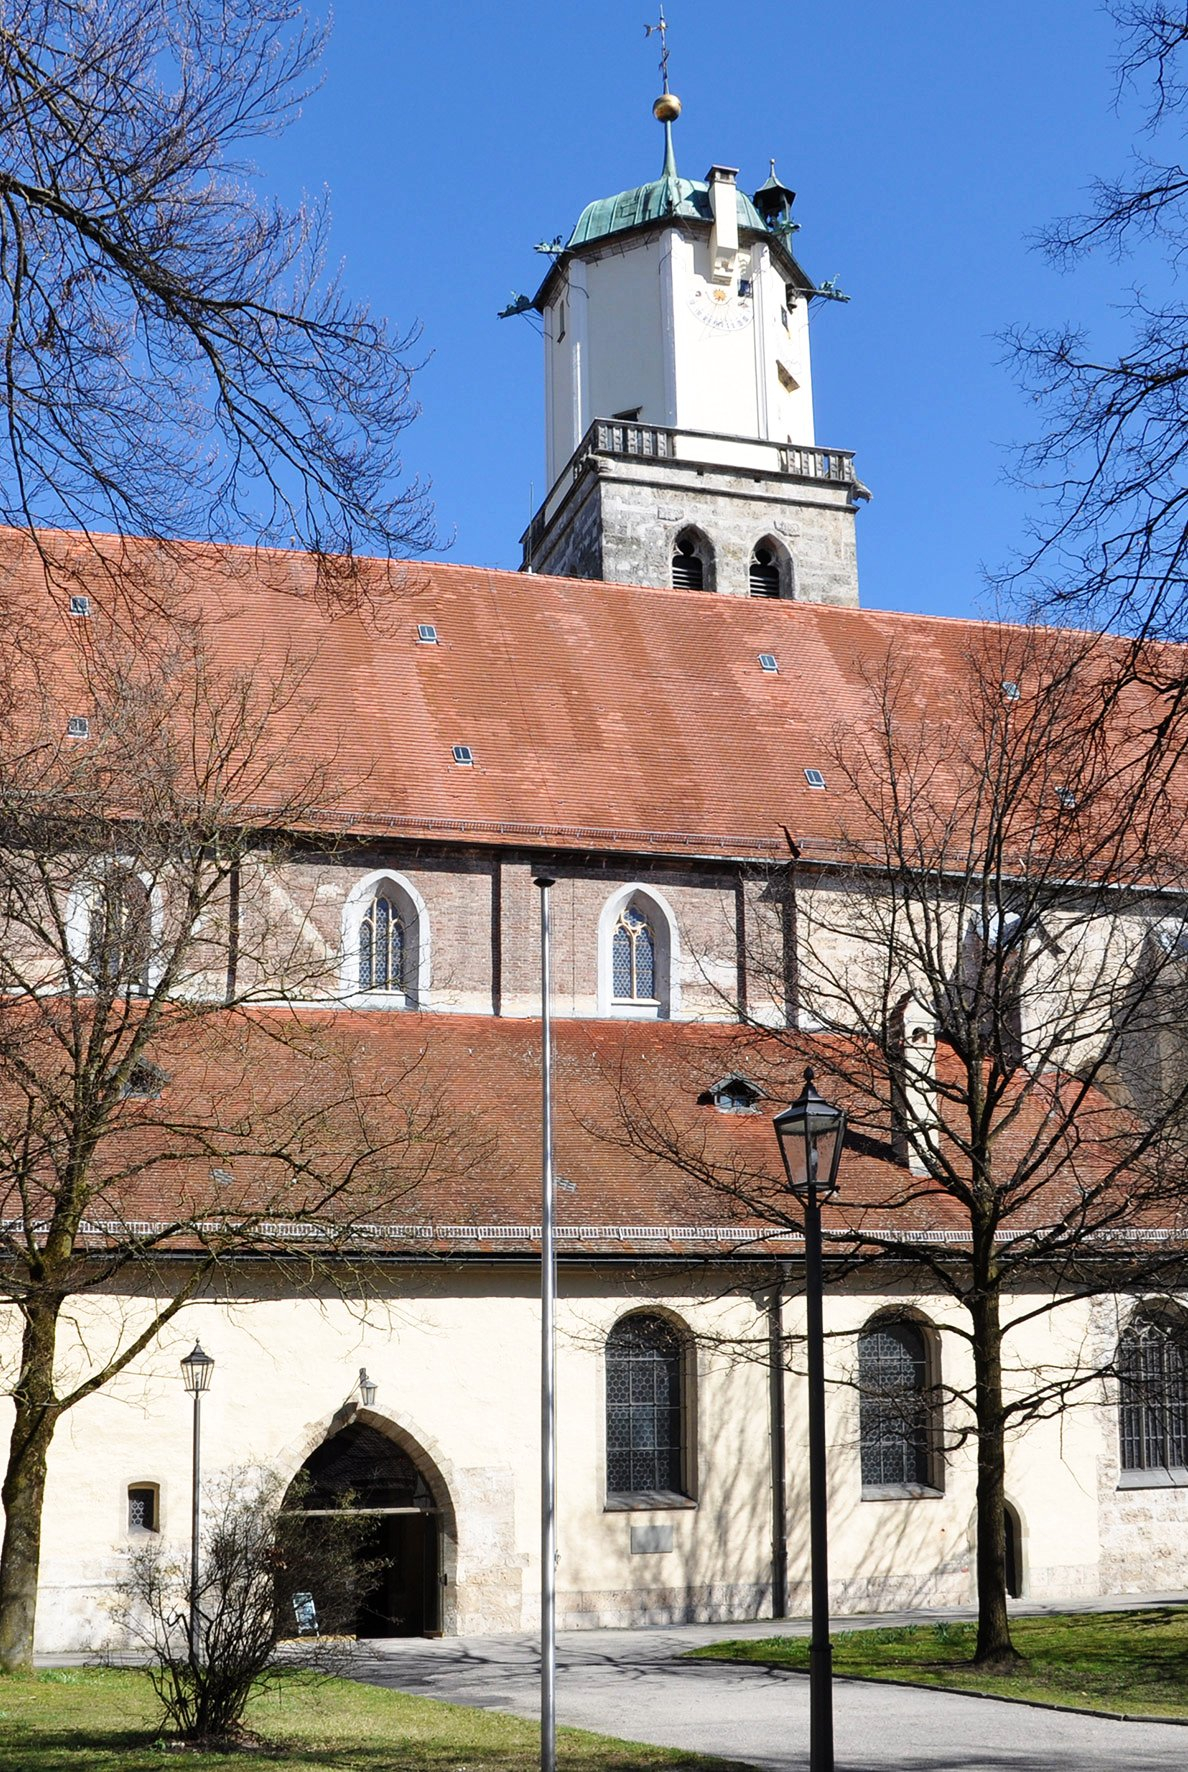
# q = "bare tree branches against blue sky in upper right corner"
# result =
<box><xmin>1009</xmin><ymin>0</ymin><xmax>1188</xmax><ymax>648</ymax></box>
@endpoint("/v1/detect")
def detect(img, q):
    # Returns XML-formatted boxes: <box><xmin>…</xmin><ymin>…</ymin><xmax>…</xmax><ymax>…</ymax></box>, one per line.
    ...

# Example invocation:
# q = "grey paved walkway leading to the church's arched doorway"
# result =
<box><xmin>358</xmin><ymin>1595</ymin><xmax>1188</xmax><ymax>1772</ymax></box>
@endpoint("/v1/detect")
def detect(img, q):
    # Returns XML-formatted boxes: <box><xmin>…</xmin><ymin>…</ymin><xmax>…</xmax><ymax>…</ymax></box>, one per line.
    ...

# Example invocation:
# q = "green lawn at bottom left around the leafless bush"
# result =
<box><xmin>0</xmin><ymin>1667</ymin><xmax>723</xmax><ymax>1772</ymax></box>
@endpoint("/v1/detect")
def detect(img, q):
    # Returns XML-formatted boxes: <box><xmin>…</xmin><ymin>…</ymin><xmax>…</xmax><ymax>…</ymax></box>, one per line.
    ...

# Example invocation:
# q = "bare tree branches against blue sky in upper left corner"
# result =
<box><xmin>0</xmin><ymin>0</ymin><xmax>429</xmax><ymax>574</ymax></box>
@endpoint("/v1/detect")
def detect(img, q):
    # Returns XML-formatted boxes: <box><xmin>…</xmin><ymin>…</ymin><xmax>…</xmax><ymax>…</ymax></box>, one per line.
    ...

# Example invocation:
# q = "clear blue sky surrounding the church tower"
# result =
<box><xmin>259</xmin><ymin>0</ymin><xmax>1163</xmax><ymax>615</ymax></box>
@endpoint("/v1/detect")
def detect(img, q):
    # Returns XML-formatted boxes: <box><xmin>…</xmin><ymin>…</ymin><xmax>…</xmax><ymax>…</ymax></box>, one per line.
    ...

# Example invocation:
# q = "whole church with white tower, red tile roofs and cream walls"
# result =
<box><xmin>6</xmin><ymin>93</ymin><xmax>1188</xmax><ymax>1652</ymax></box>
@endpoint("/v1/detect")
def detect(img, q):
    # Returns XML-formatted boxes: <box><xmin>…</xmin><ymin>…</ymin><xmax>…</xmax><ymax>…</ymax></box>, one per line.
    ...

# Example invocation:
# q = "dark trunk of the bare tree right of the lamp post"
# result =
<box><xmin>970</xmin><ymin>1285</ymin><xmax>1020</xmax><ymax>1667</ymax></box>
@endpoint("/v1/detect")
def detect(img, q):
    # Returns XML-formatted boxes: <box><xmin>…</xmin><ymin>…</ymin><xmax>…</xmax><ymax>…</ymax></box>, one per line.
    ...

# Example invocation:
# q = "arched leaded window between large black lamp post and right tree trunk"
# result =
<box><xmin>858</xmin><ymin>1320</ymin><xmax>934</xmax><ymax>1488</ymax></box>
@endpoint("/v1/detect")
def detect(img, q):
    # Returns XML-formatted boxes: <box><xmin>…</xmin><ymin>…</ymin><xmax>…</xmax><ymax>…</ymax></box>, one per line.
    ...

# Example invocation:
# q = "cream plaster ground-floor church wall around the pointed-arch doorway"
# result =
<box><xmin>6</xmin><ymin>1263</ymin><xmax>1163</xmax><ymax>1652</ymax></box>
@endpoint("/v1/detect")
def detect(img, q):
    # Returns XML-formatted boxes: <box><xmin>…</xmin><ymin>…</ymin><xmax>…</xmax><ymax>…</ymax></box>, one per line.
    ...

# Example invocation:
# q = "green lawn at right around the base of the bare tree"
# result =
<box><xmin>692</xmin><ymin>1605</ymin><xmax>1188</xmax><ymax>1715</ymax></box>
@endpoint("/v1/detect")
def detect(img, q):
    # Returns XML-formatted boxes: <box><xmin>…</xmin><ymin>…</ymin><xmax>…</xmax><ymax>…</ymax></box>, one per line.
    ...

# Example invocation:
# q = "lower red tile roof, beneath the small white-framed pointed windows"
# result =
<box><xmin>27</xmin><ymin>1010</ymin><xmax>1170</xmax><ymax>1258</ymax></box>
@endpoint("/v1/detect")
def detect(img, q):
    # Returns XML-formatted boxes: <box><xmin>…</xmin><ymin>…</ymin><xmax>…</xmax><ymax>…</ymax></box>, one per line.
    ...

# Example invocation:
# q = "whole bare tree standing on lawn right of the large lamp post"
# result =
<box><xmin>605</xmin><ymin>629</ymin><xmax>1188</xmax><ymax>1664</ymax></box>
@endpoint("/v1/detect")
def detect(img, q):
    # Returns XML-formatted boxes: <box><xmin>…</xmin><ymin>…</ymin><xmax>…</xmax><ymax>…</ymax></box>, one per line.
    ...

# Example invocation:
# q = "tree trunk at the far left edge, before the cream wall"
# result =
<box><xmin>0</xmin><ymin>1304</ymin><xmax>59</xmax><ymax>1673</ymax></box>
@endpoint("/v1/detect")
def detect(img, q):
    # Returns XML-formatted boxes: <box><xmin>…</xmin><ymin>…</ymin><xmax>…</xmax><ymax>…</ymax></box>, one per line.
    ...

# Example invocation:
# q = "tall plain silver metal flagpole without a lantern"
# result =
<box><xmin>535</xmin><ymin>875</ymin><xmax>557</xmax><ymax>1772</ymax></box>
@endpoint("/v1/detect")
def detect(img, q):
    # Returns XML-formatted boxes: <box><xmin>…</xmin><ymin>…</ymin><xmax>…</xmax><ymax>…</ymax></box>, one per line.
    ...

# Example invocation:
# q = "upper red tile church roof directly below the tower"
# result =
<box><xmin>5</xmin><ymin>537</ymin><xmax>1170</xmax><ymax>856</ymax></box>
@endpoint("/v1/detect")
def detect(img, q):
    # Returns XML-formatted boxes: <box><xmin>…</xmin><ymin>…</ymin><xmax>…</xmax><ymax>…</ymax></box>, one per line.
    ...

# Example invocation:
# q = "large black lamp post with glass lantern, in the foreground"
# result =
<box><xmin>773</xmin><ymin>1067</ymin><xmax>846</xmax><ymax>1772</ymax></box>
